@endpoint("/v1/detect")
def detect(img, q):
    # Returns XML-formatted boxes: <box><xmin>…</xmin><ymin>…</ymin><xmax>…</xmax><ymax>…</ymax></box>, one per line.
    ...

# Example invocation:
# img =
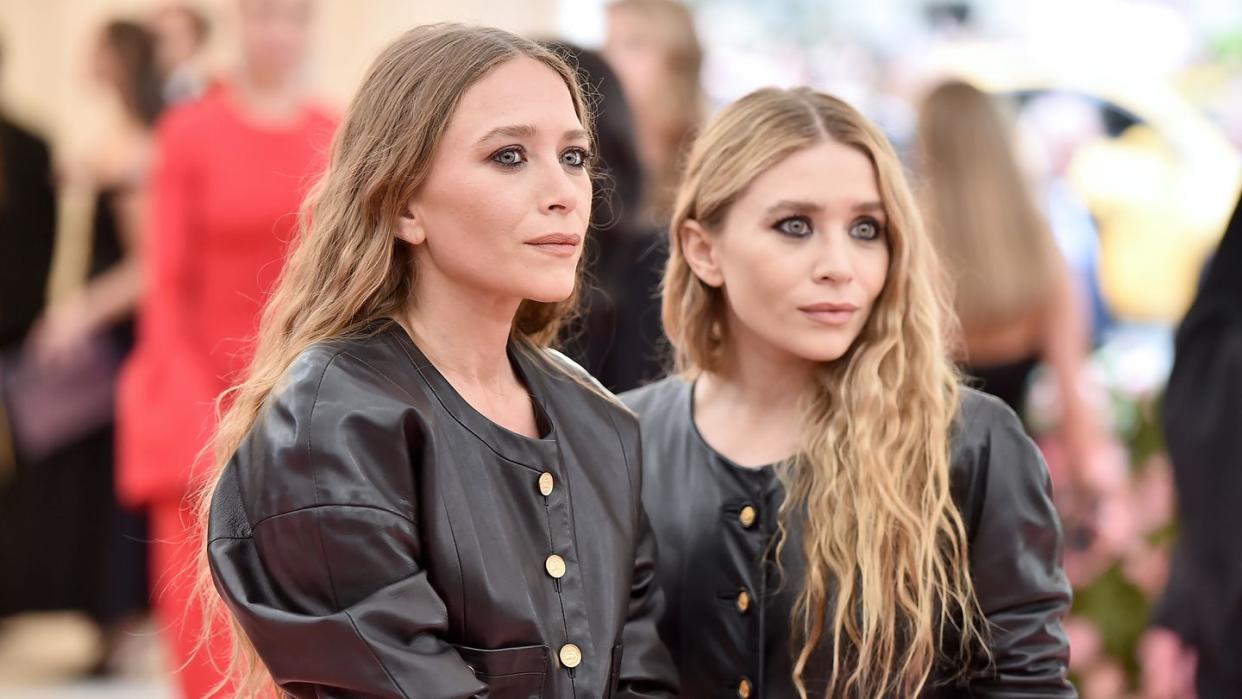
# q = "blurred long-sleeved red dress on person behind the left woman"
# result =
<box><xmin>117</xmin><ymin>87</ymin><xmax>337</xmax><ymax>698</ymax></box>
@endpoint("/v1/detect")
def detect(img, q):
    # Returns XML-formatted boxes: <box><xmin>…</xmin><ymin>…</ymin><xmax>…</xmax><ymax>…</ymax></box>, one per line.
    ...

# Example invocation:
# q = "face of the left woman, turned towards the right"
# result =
<box><xmin>399</xmin><ymin>57</ymin><xmax>591</xmax><ymax>309</ymax></box>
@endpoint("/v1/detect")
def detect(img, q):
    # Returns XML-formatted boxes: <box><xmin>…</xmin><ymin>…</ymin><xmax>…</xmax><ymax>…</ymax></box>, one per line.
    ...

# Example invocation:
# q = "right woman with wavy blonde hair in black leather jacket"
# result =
<box><xmin>622</xmin><ymin>88</ymin><xmax>1074</xmax><ymax>699</ymax></box>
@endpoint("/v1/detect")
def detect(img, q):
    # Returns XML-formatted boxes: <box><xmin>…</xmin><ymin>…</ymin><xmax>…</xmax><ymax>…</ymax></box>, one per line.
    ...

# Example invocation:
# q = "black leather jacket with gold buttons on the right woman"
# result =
<box><xmin>622</xmin><ymin>377</ymin><xmax>1074</xmax><ymax>699</ymax></box>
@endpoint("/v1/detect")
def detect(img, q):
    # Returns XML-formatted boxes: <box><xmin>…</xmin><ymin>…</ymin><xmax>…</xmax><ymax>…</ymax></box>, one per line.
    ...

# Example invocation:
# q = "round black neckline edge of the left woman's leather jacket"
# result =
<box><xmin>389</xmin><ymin>319</ymin><xmax>556</xmax><ymax>469</ymax></box>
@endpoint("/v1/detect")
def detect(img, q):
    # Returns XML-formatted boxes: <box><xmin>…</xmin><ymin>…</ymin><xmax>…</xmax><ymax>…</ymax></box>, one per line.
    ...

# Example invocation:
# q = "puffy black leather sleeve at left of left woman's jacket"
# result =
<box><xmin>209</xmin><ymin>356</ymin><xmax>486</xmax><ymax>699</ymax></box>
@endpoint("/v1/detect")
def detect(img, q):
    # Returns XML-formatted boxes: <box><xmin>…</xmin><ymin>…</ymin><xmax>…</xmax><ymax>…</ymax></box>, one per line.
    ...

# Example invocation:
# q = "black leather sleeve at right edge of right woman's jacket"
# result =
<box><xmin>961</xmin><ymin>392</ymin><xmax>1077</xmax><ymax>698</ymax></box>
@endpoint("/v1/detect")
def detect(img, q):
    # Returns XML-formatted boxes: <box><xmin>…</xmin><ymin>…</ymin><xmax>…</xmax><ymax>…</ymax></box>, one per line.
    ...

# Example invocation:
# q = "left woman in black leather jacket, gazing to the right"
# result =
<box><xmin>205</xmin><ymin>25</ymin><xmax>676</xmax><ymax>699</ymax></box>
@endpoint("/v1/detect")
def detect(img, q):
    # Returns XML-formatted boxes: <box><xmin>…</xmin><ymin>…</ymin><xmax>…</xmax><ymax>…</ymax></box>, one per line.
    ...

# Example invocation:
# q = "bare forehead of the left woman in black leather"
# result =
<box><xmin>445</xmin><ymin>56</ymin><xmax>582</xmax><ymax>140</ymax></box>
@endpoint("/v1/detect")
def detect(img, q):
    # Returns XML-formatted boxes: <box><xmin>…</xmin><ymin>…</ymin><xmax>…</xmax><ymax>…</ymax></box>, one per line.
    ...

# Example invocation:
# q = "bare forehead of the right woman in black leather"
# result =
<box><xmin>738</xmin><ymin>140</ymin><xmax>882</xmax><ymax>211</ymax></box>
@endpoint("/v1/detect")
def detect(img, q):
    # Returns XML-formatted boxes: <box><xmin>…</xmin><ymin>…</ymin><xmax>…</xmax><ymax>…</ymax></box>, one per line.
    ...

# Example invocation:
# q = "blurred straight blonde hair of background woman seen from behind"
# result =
<box><xmin>918</xmin><ymin>81</ymin><xmax>1062</xmax><ymax>333</ymax></box>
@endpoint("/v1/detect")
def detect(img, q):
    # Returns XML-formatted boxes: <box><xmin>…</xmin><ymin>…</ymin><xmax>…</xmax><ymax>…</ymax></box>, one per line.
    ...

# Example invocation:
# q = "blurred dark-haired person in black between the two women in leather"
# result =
<box><xmin>549</xmin><ymin>42</ymin><xmax>667</xmax><ymax>392</ymax></box>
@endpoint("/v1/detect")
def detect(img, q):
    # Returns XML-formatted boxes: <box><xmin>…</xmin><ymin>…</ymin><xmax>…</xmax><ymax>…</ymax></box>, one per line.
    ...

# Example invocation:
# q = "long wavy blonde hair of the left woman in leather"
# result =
<box><xmin>197</xmin><ymin>25</ymin><xmax>591</xmax><ymax>697</ymax></box>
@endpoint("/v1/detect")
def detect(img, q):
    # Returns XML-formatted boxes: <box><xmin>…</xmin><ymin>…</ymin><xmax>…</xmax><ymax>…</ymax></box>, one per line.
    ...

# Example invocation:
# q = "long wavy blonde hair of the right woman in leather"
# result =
<box><xmin>663</xmin><ymin>88</ymin><xmax>986</xmax><ymax>698</ymax></box>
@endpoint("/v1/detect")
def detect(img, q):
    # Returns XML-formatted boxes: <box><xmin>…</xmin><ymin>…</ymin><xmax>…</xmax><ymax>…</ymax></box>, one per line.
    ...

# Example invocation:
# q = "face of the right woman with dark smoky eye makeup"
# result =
<box><xmin>682</xmin><ymin>140</ymin><xmax>888</xmax><ymax>363</ymax></box>
